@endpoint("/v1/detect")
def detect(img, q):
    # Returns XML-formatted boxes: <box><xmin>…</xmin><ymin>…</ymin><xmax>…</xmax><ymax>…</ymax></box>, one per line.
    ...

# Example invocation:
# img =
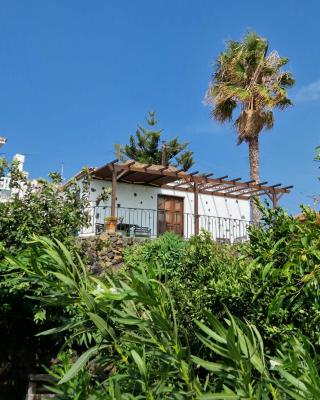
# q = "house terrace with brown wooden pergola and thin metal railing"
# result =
<box><xmin>78</xmin><ymin>160</ymin><xmax>292</xmax><ymax>243</ymax></box>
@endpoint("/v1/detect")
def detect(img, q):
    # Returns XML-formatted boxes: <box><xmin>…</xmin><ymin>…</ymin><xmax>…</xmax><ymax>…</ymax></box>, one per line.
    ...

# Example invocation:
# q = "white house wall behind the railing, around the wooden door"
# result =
<box><xmin>80</xmin><ymin>179</ymin><xmax>250</xmax><ymax>241</ymax></box>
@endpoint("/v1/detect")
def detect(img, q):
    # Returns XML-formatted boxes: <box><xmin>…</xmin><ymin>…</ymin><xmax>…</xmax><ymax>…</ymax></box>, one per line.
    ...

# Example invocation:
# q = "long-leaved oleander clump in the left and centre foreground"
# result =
<box><xmin>7</xmin><ymin>239</ymin><xmax>201</xmax><ymax>399</ymax></box>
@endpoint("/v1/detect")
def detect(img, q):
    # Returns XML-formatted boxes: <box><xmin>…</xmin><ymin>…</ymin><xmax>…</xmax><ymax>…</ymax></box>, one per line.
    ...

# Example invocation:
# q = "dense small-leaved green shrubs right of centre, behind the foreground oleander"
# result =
<box><xmin>127</xmin><ymin>208</ymin><xmax>320</xmax><ymax>353</ymax></box>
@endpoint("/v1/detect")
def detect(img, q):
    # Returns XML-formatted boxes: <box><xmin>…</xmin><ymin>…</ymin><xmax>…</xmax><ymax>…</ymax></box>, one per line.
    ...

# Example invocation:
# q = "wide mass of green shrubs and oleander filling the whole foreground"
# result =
<box><xmin>0</xmin><ymin>177</ymin><xmax>320</xmax><ymax>400</ymax></box>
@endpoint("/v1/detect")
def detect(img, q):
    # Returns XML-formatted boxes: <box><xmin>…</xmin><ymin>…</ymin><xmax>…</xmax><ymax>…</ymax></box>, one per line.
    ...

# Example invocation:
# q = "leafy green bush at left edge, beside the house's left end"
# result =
<box><xmin>0</xmin><ymin>159</ymin><xmax>90</xmax><ymax>253</ymax></box>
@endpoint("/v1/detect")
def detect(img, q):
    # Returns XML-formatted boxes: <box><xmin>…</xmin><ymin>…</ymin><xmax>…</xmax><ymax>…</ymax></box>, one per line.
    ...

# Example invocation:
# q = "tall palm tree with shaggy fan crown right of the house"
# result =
<box><xmin>205</xmin><ymin>32</ymin><xmax>294</xmax><ymax>222</ymax></box>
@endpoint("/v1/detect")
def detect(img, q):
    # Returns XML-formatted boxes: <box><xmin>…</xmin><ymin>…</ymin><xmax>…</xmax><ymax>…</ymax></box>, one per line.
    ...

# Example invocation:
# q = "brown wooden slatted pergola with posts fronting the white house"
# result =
<box><xmin>92</xmin><ymin>160</ymin><xmax>293</xmax><ymax>234</ymax></box>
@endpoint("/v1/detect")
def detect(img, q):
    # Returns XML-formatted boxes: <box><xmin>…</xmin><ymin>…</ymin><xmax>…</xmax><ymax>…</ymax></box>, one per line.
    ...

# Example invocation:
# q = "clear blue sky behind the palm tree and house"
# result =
<box><xmin>0</xmin><ymin>0</ymin><xmax>320</xmax><ymax>213</ymax></box>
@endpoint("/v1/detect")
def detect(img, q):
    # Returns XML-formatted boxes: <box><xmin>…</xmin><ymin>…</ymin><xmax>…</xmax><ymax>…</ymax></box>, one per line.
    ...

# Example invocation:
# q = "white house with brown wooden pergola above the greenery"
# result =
<box><xmin>76</xmin><ymin>161</ymin><xmax>291</xmax><ymax>242</ymax></box>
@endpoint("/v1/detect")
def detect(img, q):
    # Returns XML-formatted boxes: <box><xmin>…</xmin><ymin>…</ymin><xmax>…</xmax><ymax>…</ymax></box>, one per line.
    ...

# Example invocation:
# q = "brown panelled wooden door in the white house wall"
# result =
<box><xmin>158</xmin><ymin>195</ymin><xmax>183</xmax><ymax>236</ymax></box>
